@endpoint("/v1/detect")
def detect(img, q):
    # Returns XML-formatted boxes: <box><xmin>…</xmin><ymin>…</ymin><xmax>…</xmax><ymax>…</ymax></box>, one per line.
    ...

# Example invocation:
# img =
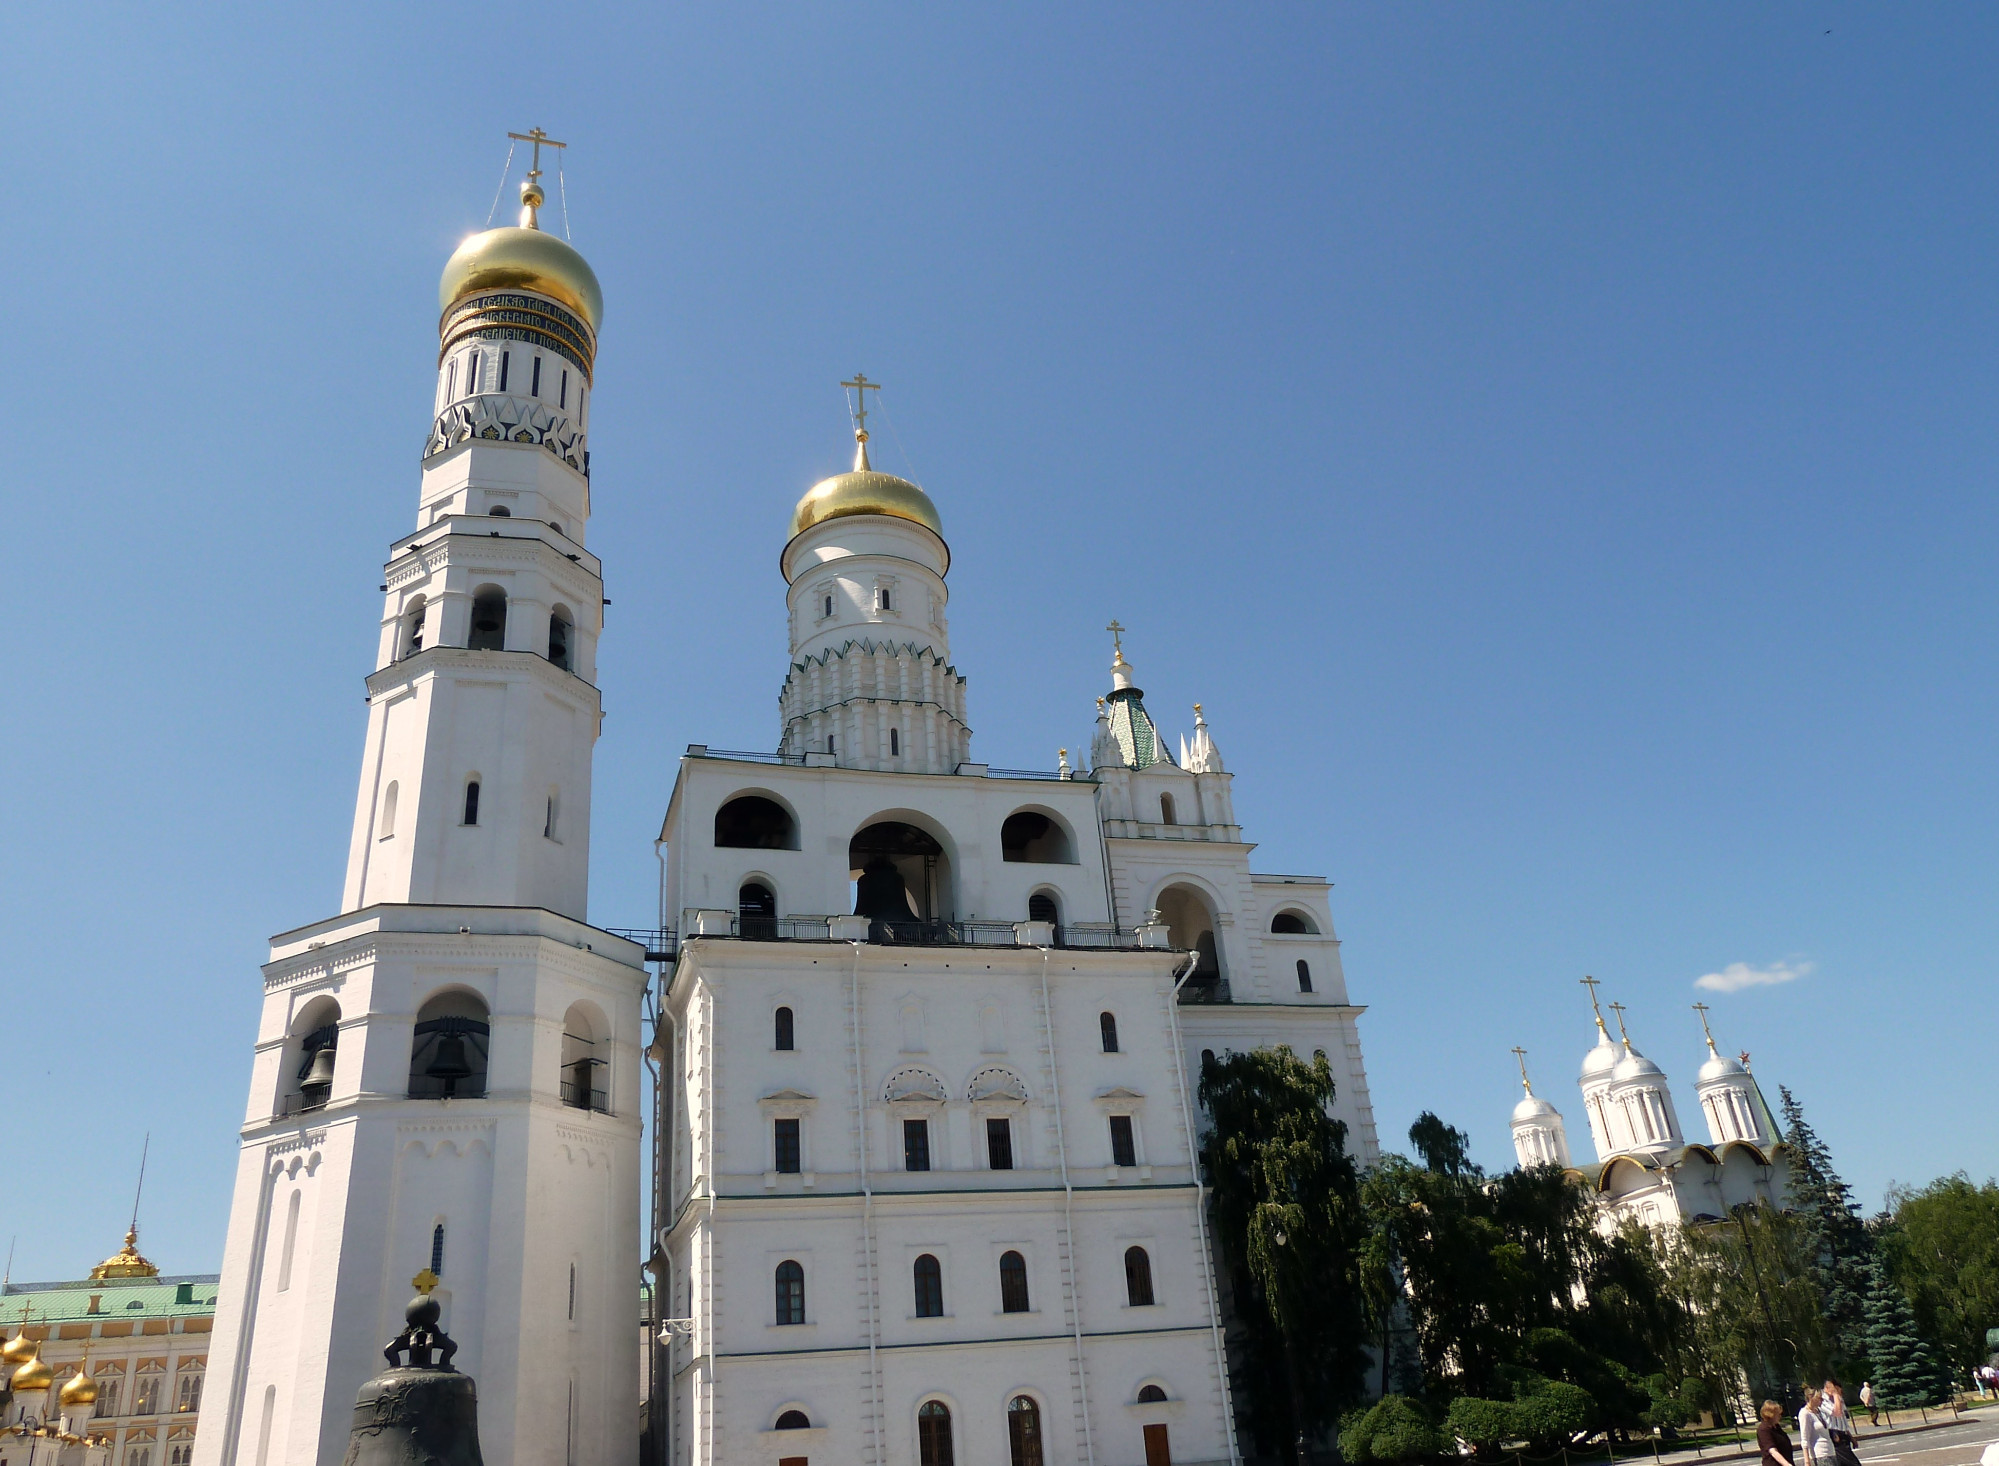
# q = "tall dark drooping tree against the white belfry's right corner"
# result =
<box><xmin>1201</xmin><ymin>1046</ymin><xmax>1367</xmax><ymax>1450</ymax></box>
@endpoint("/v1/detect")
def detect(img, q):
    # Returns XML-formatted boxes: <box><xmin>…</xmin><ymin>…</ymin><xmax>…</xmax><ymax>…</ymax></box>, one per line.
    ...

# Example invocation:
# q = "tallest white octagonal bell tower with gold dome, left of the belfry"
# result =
<box><xmin>196</xmin><ymin>143</ymin><xmax>646</xmax><ymax>1466</ymax></box>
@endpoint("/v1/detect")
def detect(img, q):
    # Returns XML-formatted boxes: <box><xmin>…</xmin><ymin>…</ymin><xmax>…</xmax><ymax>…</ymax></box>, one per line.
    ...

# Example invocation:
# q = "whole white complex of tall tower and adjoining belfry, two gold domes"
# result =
<box><xmin>196</xmin><ymin>134</ymin><xmax>1375</xmax><ymax>1466</ymax></box>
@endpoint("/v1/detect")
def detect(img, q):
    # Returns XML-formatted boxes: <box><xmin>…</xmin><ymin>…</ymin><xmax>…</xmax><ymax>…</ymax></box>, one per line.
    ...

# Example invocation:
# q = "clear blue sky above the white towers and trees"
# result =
<box><xmin>0</xmin><ymin>4</ymin><xmax>1999</xmax><ymax>1278</ymax></box>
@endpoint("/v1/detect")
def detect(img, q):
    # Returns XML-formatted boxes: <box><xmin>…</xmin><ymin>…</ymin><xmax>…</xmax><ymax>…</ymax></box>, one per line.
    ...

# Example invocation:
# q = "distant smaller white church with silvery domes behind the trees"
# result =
<box><xmin>1513</xmin><ymin>978</ymin><xmax>1789</xmax><ymax>1228</ymax></box>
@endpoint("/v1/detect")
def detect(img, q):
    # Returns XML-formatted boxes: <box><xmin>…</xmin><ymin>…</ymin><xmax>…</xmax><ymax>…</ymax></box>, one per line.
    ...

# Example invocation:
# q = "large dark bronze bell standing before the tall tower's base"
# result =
<box><xmin>344</xmin><ymin>1294</ymin><xmax>486</xmax><ymax>1466</ymax></box>
